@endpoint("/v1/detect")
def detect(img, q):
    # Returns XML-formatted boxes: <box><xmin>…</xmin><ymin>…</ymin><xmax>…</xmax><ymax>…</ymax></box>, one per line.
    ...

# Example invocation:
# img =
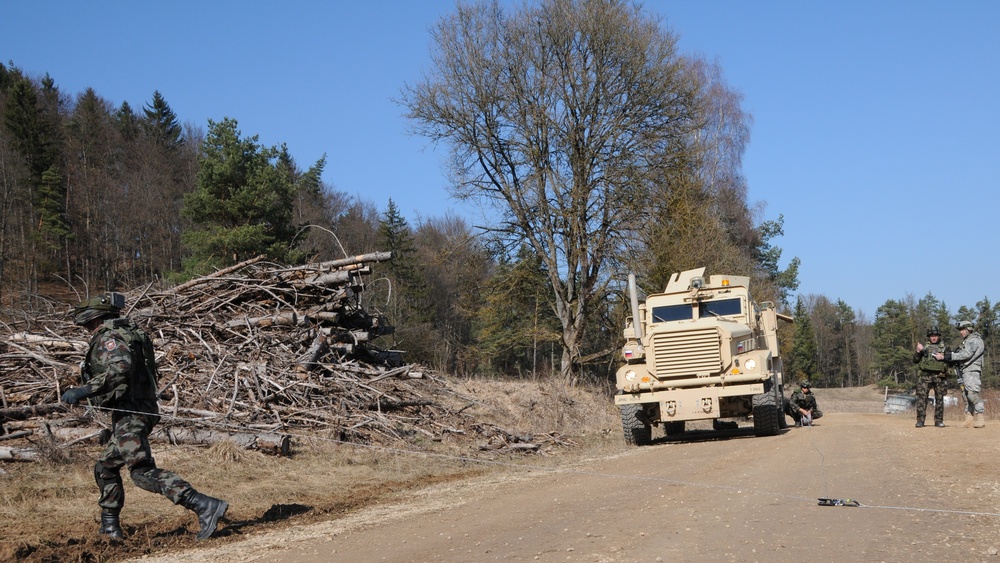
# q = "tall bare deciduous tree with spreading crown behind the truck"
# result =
<box><xmin>402</xmin><ymin>0</ymin><xmax>701</xmax><ymax>377</ymax></box>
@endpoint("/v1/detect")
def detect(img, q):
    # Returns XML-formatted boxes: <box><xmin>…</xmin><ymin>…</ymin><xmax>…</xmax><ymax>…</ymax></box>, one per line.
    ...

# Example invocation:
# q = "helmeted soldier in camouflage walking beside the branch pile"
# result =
<box><xmin>62</xmin><ymin>293</ymin><xmax>229</xmax><ymax>540</ymax></box>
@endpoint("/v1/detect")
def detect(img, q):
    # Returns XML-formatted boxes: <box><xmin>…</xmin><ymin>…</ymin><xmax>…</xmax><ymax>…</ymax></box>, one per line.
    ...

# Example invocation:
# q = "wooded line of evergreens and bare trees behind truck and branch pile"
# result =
<box><xmin>11</xmin><ymin>0</ymin><xmax>995</xmax><ymax>385</ymax></box>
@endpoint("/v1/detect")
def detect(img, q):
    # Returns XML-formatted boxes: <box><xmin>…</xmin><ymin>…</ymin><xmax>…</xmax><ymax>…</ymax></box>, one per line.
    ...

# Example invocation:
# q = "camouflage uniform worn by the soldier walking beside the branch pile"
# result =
<box><xmin>84</xmin><ymin>318</ymin><xmax>191</xmax><ymax>511</ymax></box>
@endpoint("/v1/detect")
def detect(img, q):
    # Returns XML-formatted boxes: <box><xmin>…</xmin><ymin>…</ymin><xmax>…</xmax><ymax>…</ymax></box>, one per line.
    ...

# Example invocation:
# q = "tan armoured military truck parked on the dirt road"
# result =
<box><xmin>615</xmin><ymin>268</ymin><xmax>792</xmax><ymax>445</ymax></box>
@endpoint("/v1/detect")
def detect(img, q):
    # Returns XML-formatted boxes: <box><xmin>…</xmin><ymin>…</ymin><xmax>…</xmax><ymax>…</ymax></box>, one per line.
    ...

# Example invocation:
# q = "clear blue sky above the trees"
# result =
<box><xmin>0</xmin><ymin>0</ymin><xmax>1000</xmax><ymax>318</ymax></box>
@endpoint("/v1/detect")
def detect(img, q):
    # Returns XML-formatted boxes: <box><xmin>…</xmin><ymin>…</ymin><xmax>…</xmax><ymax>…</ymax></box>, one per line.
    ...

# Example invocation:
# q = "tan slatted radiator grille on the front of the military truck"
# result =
<box><xmin>653</xmin><ymin>328</ymin><xmax>722</xmax><ymax>379</ymax></box>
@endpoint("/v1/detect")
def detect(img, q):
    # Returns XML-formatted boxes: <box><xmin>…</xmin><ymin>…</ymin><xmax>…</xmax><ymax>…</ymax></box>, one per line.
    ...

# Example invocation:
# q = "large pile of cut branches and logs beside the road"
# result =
<box><xmin>0</xmin><ymin>253</ymin><xmax>521</xmax><ymax>457</ymax></box>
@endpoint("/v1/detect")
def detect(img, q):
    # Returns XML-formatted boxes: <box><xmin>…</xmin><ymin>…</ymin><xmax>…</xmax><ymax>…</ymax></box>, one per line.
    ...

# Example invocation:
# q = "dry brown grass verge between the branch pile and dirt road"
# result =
<box><xmin>0</xmin><ymin>380</ymin><xmax>621</xmax><ymax>562</ymax></box>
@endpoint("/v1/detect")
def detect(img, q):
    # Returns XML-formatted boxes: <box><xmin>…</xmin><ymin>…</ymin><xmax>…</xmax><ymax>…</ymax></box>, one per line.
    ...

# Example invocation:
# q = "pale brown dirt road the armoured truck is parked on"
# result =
<box><xmin>144</xmin><ymin>413</ymin><xmax>1000</xmax><ymax>563</ymax></box>
